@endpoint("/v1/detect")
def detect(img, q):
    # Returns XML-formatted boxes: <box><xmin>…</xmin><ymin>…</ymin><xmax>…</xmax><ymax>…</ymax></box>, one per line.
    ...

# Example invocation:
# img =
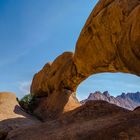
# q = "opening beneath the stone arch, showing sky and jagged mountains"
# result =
<box><xmin>76</xmin><ymin>72</ymin><xmax>140</xmax><ymax>110</ymax></box>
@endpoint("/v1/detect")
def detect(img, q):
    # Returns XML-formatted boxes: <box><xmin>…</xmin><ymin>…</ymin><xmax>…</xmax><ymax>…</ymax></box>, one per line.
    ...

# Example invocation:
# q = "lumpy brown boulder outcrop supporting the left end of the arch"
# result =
<box><xmin>31</xmin><ymin>52</ymin><xmax>80</xmax><ymax>119</ymax></box>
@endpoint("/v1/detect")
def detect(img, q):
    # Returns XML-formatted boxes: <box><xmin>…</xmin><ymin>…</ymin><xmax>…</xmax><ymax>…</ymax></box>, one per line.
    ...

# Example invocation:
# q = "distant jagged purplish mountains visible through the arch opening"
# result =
<box><xmin>81</xmin><ymin>91</ymin><xmax>140</xmax><ymax>110</ymax></box>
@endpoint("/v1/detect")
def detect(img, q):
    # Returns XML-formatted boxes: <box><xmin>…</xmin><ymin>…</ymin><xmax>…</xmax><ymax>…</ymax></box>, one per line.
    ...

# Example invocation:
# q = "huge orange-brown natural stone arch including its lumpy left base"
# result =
<box><xmin>31</xmin><ymin>0</ymin><xmax>140</xmax><ymax>118</ymax></box>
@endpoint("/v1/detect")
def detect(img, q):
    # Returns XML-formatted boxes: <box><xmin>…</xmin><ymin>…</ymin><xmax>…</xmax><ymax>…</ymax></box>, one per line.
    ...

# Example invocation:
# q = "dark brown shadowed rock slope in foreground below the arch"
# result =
<box><xmin>6</xmin><ymin>101</ymin><xmax>140</xmax><ymax>140</ymax></box>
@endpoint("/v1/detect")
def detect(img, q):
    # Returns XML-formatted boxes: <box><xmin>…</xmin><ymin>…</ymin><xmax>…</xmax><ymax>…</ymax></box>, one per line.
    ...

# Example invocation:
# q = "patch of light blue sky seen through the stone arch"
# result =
<box><xmin>77</xmin><ymin>73</ymin><xmax>140</xmax><ymax>99</ymax></box>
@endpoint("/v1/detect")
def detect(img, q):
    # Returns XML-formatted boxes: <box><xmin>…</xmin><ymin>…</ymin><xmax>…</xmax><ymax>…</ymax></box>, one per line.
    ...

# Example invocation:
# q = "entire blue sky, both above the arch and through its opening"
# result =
<box><xmin>0</xmin><ymin>0</ymin><xmax>140</xmax><ymax>99</ymax></box>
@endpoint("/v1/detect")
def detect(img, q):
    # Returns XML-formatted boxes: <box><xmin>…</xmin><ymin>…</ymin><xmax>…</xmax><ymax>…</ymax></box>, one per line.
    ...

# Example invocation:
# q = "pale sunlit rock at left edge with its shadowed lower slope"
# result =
<box><xmin>0</xmin><ymin>92</ymin><xmax>40</xmax><ymax>140</ymax></box>
